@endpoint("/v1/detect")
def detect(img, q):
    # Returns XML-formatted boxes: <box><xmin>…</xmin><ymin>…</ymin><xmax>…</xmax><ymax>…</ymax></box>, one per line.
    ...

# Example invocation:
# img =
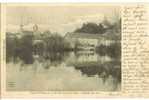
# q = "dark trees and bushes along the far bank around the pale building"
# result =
<box><xmin>6</xmin><ymin>17</ymin><xmax>121</xmax><ymax>64</ymax></box>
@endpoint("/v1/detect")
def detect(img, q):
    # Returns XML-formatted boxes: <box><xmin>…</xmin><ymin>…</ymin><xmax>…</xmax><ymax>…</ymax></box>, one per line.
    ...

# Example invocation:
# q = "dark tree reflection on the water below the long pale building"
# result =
<box><xmin>74</xmin><ymin>61</ymin><xmax>121</xmax><ymax>83</ymax></box>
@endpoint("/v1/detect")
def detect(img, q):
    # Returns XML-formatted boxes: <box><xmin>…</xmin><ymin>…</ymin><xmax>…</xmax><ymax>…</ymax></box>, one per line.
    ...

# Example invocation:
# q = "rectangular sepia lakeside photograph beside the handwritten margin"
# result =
<box><xmin>6</xmin><ymin>4</ymin><xmax>121</xmax><ymax>92</ymax></box>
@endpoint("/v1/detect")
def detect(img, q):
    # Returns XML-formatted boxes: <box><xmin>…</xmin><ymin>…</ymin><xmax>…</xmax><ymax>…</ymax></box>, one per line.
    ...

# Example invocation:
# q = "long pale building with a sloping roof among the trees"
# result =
<box><xmin>65</xmin><ymin>33</ymin><xmax>113</xmax><ymax>50</ymax></box>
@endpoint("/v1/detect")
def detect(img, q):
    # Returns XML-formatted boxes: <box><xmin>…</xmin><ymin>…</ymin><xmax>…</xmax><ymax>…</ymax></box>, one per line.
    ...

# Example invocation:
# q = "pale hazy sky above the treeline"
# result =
<box><xmin>6</xmin><ymin>4</ymin><xmax>120</xmax><ymax>35</ymax></box>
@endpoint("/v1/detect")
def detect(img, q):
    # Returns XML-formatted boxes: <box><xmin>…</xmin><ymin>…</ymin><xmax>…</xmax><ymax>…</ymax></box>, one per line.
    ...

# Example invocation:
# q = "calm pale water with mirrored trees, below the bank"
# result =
<box><xmin>7</xmin><ymin>51</ymin><xmax>121</xmax><ymax>91</ymax></box>
